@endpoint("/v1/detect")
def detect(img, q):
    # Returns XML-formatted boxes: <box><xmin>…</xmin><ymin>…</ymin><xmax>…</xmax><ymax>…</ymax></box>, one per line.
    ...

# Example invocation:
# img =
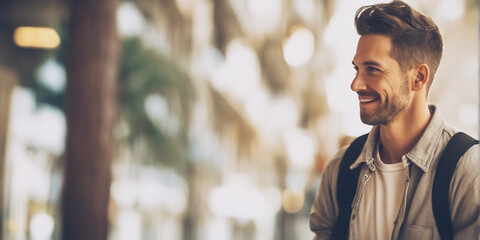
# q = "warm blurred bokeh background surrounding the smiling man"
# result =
<box><xmin>0</xmin><ymin>0</ymin><xmax>479</xmax><ymax>240</ymax></box>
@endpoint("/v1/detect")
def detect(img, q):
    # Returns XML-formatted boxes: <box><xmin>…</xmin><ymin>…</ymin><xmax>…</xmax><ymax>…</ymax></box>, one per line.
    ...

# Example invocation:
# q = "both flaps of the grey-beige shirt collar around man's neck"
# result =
<box><xmin>350</xmin><ymin>105</ymin><xmax>444</xmax><ymax>172</ymax></box>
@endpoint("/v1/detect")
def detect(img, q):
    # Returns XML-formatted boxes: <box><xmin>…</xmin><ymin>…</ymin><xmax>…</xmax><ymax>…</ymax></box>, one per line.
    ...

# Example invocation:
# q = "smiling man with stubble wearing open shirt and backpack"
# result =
<box><xmin>310</xmin><ymin>1</ymin><xmax>480</xmax><ymax>239</ymax></box>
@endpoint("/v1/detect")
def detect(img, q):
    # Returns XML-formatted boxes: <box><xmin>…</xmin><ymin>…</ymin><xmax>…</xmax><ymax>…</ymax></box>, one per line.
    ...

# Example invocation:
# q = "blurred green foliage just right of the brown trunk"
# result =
<box><xmin>119</xmin><ymin>38</ymin><xmax>195</xmax><ymax>165</ymax></box>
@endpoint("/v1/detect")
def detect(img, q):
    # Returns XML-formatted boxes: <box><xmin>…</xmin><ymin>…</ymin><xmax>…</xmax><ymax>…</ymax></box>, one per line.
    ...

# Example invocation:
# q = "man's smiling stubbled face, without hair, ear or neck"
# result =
<box><xmin>351</xmin><ymin>34</ymin><xmax>410</xmax><ymax>125</ymax></box>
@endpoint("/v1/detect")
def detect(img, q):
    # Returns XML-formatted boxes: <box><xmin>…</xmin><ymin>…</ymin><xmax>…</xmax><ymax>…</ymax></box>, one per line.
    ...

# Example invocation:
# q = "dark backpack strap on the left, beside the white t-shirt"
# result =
<box><xmin>330</xmin><ymin>134</ymin><xmax>368</xmax><ymax>239</ymax></box>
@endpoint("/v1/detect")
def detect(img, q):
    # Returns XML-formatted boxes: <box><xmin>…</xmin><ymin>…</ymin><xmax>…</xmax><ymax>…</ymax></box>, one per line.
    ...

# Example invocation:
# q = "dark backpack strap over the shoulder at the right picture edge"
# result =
<box><xmin>432</xmin><ymin>132</ymin><xmax>478</xmax><ymax>240</ymax></box>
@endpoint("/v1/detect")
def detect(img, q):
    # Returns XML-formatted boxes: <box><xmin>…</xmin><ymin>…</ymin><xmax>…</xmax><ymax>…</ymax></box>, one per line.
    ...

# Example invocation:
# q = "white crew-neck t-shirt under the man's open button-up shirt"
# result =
<box><xmin>354</xmin><ymin>144</ymin><xmax>406</xmax><ymax>240</ymax></box>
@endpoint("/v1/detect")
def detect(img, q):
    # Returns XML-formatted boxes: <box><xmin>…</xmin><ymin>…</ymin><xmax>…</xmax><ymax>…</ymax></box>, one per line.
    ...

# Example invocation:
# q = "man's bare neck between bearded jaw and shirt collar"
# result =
<box><xmin>380</xmin><ymin>104</ymin><xmax>431</xmax><ymax>164</ymax></box>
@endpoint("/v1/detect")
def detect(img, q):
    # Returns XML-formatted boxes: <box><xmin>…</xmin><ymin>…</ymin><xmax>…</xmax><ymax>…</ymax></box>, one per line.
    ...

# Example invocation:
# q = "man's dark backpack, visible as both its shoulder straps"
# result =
<box><xmin>331</xmin><ymin>132</ymin><xmax>478</xmax><ymax>240</ymax></box>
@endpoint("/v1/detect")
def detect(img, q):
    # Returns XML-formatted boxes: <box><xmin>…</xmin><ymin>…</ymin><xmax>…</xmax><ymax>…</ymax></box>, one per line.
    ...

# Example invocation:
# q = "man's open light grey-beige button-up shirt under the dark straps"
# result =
<box><xmin>310</xmin><ymin>105</ymin><xmax>480</xmax><ymax>240</ymax></box>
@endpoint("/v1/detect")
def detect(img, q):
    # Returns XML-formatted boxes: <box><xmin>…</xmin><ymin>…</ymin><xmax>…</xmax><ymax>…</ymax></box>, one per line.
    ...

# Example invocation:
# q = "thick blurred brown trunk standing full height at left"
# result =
<box><xmin>62</xmin><ymin>0</ymin><xmax>118</xmax><ymax>240</ymax></box>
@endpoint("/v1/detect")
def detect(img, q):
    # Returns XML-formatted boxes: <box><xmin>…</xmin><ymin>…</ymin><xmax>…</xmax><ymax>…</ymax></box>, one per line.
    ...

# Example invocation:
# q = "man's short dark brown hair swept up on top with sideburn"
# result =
<box><xmin>355</xmin><ymin>0</ymin><xmax>443</xmax><ymax>94</ymax></box>
